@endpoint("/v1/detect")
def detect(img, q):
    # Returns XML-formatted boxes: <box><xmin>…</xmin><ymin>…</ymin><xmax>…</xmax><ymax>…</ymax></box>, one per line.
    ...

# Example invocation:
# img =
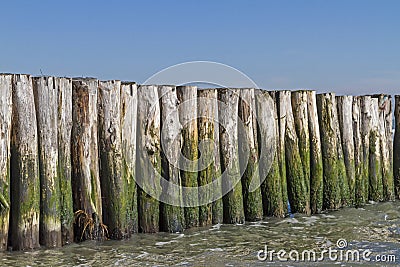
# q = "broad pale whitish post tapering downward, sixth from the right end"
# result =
<box><xmin>336</xmin><ymin>96</ymin><xmax>356</xmax><ymax>205</ymax></box>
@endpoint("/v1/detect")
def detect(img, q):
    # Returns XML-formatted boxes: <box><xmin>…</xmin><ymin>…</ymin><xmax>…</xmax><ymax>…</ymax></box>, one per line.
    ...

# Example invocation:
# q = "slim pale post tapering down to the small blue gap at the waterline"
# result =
<box><xmin>275</xmin><ymin>91</ymin><xmax>291</xmax><ymax>214</ymax></box>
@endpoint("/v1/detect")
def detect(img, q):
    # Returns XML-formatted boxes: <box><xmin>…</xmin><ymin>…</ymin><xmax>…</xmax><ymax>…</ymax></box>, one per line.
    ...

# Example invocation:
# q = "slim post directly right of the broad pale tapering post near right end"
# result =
<box><xmin>352</xmin><ymin>96</ymin><xmax>368</xmax><ymax>207</ymax></box>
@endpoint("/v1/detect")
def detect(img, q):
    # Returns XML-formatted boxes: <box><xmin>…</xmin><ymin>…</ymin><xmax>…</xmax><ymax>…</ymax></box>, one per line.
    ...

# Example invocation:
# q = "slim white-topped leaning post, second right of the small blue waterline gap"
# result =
<box><xmin>307</xmin><ymin>91</ymin><xmax>324</xmax><ymax>213</ymax></box>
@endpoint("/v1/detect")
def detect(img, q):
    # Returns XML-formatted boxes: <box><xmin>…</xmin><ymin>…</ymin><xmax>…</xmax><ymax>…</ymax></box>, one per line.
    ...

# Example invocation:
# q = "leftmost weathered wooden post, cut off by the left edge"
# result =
<box><xmin>0</xmin><ymin>74</ymin><xmax>13</xmax><ymax>251</ymax></box>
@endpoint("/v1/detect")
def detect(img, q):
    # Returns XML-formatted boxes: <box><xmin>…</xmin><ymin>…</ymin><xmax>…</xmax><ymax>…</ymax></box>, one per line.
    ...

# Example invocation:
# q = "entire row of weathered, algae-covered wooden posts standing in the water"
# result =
<box><xmin>0</xmin><ymin>74</ymin><xmax>400</xmax><ymax>250</ymax></box>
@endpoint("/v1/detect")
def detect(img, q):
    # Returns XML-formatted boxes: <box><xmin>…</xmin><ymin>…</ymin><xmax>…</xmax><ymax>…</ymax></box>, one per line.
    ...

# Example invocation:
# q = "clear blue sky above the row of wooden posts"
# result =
<box><xmin>0</xmin><ymin>0</ymin><xmax>400</xmax><ymax>94</ymax></box>
